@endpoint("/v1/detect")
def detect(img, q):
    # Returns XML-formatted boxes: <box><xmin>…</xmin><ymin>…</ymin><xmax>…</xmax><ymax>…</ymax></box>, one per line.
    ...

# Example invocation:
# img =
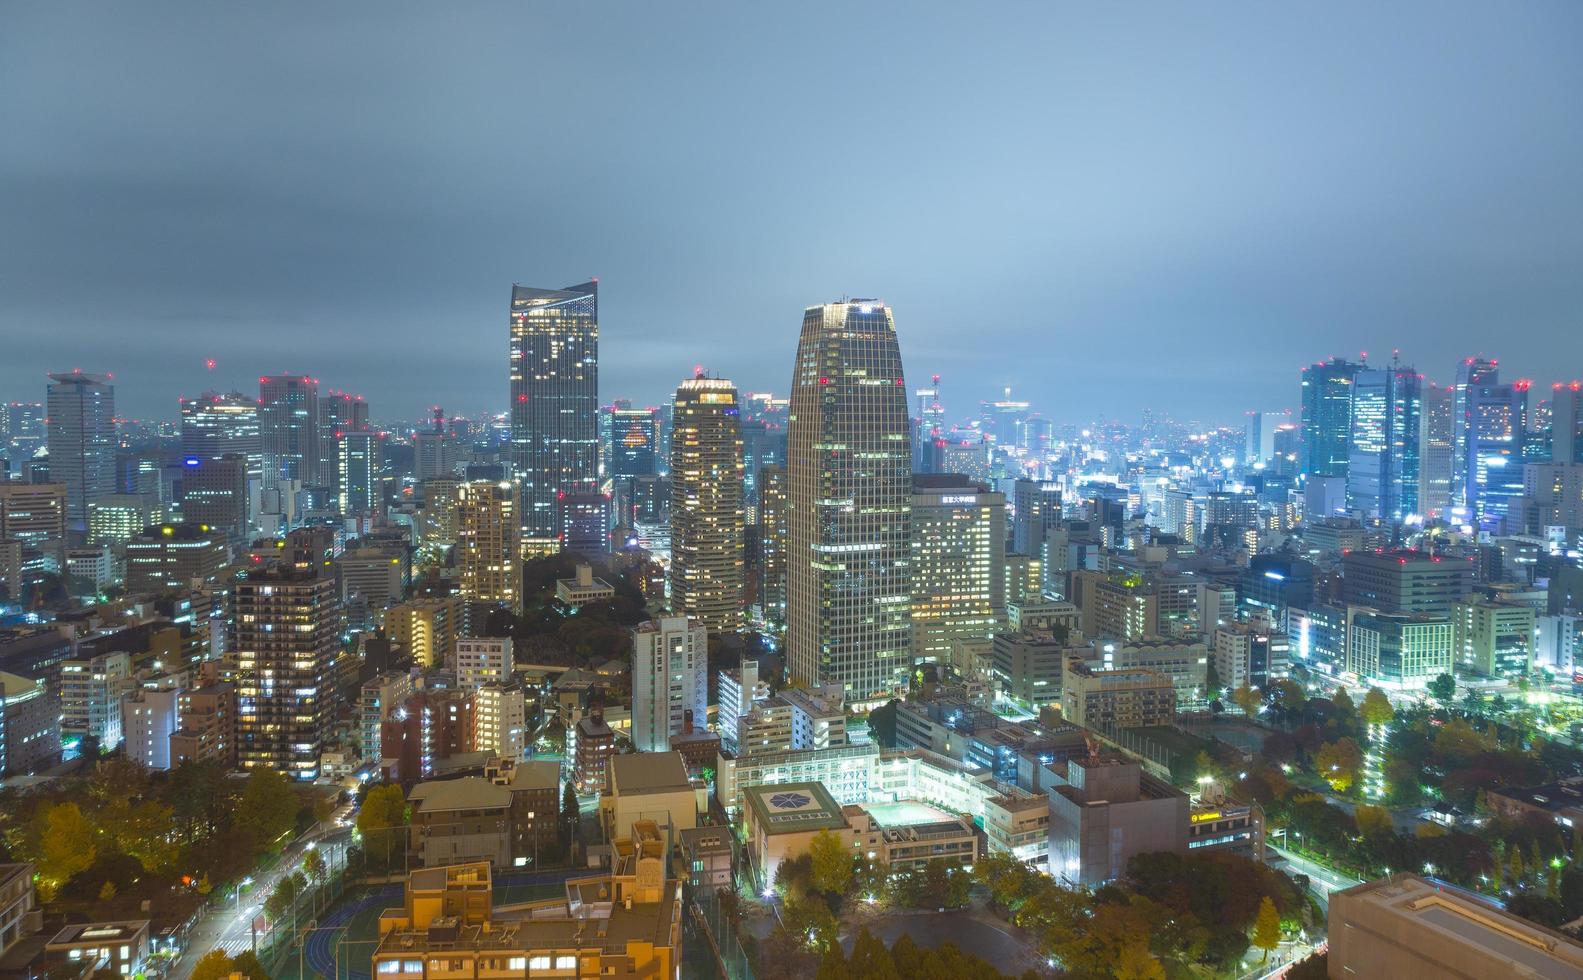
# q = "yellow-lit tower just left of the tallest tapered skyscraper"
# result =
<box><xmin>671</xmin><ymin>375</ymin><xmax>744</xmax><ymax>633</ymax></box>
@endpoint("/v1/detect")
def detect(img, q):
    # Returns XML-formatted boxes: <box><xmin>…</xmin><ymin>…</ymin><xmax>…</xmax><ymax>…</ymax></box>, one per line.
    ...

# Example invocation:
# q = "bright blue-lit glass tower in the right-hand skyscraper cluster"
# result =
<box><xmin>1347</xmin><ymin>366</ymin><xmax>1423</xmax><ymax>524</ymax></box>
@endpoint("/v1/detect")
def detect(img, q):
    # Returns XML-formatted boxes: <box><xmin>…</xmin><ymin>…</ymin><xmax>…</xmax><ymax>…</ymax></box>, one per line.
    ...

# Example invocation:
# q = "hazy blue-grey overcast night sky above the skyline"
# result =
<box><xmin>0</xmin><ymin>0</ymin><xmax>1583</xmax><ymax>421</ymax></box>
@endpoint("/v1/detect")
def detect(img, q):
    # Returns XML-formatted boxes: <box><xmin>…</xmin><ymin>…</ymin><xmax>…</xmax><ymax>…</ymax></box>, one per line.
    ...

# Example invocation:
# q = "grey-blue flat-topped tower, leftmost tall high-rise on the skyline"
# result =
<box><xmin>46</xmin><ymin>370</ymin><xmax>116</xmax><ymax>532</ymax></box>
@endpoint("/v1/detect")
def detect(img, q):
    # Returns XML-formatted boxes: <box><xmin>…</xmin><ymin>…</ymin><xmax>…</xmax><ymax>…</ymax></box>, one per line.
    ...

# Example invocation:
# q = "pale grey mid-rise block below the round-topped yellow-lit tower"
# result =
<box><xmin>632</xmin><ymin>616</ymin><xmax>709</xmax><ymax>752</ymax></box>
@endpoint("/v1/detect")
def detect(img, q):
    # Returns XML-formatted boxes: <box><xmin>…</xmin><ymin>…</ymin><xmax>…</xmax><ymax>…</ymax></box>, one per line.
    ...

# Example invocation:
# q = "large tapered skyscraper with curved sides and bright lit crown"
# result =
<box><xmin>787</xmin><ymin>299</ymin><xmax>912</xmax><ymax>705</ymax></box>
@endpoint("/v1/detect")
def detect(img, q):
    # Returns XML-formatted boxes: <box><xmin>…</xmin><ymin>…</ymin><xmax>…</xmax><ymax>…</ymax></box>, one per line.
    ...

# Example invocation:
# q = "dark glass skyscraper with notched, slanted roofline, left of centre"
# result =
<box><xmin>511</xmin><ymin>280</ymin><xmax>598</xmax><ymax>549</ymax></box>
